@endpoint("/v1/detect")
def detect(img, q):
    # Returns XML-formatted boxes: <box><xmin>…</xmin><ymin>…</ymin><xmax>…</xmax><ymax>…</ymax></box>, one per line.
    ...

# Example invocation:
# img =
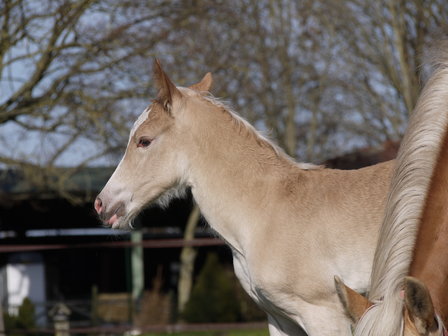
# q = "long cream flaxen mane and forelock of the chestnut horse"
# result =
<box><xmin>355</xmin><ymin>40</ymin><xmax>448</xmax><ymax>336</ymax></box>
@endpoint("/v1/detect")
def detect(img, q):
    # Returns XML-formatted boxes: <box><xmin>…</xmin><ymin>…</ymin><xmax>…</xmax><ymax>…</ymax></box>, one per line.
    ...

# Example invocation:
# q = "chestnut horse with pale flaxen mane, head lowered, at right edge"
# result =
<box><xmin>336</xmin><ymin>41</ymin><xmax>448</xmax><ymax>336</ymax></box>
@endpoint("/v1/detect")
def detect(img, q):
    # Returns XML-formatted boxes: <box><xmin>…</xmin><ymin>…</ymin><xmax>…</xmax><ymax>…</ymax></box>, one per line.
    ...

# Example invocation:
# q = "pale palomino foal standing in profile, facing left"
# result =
<box><xmin>95</xmin><ymin>62</ymin><xmax>393</xmax><ymax>336</ymax></box>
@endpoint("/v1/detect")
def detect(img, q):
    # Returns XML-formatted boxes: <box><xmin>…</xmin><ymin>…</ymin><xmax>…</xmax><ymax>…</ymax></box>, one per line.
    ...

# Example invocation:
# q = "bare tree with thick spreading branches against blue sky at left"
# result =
<box><xmin>0</xmin><ymin>0</ymin><xmax>201</xmax><ymax>197</ymax></box>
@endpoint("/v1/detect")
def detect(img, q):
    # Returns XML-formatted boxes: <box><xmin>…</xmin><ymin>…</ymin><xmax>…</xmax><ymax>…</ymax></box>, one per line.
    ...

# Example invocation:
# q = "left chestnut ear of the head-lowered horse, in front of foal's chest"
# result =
<box><xmin>334</xmin><ymin>276</ymin><xmax>372</xmax><ymax>323</ymax></box>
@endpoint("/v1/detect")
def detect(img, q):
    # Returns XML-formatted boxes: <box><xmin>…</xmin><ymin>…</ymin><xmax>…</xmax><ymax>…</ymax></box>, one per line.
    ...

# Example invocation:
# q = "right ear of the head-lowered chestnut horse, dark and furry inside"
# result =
<box><xmin>404</xmin><ymin>277</ymin><xmax>438</xmax><ymax>335</ymax></box>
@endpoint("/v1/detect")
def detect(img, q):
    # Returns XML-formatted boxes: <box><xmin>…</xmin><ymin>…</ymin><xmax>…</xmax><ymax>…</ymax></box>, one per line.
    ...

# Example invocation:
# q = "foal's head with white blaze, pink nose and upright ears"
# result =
<box><xmin>95</xmin><ymin>61</ymin><xmax>212</xmax><ymax>228</ymax></box>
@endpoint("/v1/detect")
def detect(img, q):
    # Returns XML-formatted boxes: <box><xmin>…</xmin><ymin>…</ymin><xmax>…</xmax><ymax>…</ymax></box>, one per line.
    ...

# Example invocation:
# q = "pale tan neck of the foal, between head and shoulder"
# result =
<box><xmin>188</xmin><ymin>101</ymin><xmax>299</xmax><ymax>253</ymax></box>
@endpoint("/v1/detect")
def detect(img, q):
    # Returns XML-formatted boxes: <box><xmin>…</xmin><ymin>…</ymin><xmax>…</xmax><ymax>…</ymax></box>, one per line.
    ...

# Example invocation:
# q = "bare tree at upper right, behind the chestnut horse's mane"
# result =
<box><xmin>315</xmin><ymin>0</ymin><xmax>448</xmax><ymax>143</ymax></box>
